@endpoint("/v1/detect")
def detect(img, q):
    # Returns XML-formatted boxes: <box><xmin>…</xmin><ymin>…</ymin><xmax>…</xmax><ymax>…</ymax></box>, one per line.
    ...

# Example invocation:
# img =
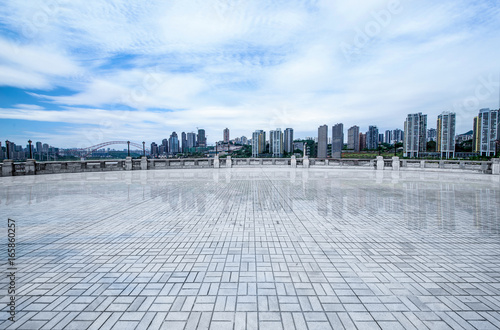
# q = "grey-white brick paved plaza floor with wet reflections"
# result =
<box><xmin>0</xmin><ymin>168</ymin><xmax>500</xmax><ymax>330</ymax></box>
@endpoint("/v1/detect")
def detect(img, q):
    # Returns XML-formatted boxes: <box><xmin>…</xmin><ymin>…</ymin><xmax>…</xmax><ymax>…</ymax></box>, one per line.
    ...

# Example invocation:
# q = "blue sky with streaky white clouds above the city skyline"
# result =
<box><xmin>0</xmin><ymin>0</ymin><xmax>500</xmax><ymax>148</ymax></box>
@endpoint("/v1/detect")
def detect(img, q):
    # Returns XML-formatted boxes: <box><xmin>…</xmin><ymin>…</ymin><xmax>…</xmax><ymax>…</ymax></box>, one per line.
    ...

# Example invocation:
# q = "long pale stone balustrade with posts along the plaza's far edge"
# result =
<box><xmin>0</xmin><ymin>156</ymin><xmax>500</xmax><ymax>176</ymax></box>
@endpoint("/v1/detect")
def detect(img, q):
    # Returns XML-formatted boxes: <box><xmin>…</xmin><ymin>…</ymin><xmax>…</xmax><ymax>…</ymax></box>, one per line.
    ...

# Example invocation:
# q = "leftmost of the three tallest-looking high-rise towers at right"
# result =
<box><xmin>403</xmin><ymin>112</ymin><xmax>427</xmax><ymax>157</ymax></box>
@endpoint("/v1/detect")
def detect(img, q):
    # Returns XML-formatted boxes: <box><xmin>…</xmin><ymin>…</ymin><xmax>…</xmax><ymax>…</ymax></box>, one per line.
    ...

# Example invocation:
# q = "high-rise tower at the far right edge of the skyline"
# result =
<box><xmin>473</xmin><ymin>108</ymin><xmax>500</xmax><ymax>156</ymax></box>
